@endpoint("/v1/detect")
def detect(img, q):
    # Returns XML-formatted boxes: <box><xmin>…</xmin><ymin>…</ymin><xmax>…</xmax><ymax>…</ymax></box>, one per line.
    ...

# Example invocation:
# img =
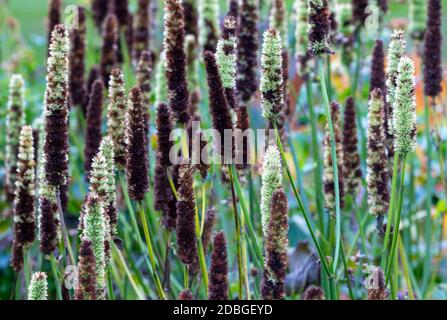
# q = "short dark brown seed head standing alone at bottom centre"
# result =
<box><xmin>208</xmin><ymin>231</ymin><xmax>228</xmax><ymax>300</ymax></box>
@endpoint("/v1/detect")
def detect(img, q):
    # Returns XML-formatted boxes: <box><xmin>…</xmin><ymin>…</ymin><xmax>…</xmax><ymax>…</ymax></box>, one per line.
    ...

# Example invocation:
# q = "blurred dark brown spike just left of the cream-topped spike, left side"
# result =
<box><xmin>84</xmin><ymin>80</ymin><xmax>104</xmax><ymax>181</ymax></box>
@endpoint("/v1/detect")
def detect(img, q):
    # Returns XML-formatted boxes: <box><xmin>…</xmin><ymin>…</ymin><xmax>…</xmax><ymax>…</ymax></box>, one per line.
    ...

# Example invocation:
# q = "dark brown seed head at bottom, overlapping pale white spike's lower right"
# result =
<box><xmin>261</xmin><ymin>188</ymin><xmax>289</xmax><ymax>300</ymax></box>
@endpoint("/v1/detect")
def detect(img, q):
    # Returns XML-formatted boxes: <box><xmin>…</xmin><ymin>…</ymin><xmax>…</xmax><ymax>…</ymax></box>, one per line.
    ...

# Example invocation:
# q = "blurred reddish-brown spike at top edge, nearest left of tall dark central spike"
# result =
<box><xmin>133</xmin><ymin>0</ymin><xmax>150</xmax><ymax>63</ymax></box>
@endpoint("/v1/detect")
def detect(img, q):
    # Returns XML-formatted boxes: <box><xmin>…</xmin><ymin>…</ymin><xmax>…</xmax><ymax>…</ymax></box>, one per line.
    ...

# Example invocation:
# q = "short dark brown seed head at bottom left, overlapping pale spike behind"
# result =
<box><xmin>75</xmin><ymin>239</ymin><xmax>97</xmax><ymax>300</ymax></box>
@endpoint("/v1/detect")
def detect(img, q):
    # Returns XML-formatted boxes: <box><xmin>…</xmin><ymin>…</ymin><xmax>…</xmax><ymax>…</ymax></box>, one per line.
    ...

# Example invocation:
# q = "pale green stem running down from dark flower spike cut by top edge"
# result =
<box><xmin>318</xmin><ymin>57</ymin><xmax>341</xmax><ymax>273</ymax></box>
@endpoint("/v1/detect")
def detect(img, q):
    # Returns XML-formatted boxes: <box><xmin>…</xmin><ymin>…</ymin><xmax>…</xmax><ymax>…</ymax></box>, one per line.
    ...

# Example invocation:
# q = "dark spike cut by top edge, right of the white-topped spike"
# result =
<box><xmin>236</xmin><ymin>0</ymin><xmax>259</xmax><ymax>105</ymax></box>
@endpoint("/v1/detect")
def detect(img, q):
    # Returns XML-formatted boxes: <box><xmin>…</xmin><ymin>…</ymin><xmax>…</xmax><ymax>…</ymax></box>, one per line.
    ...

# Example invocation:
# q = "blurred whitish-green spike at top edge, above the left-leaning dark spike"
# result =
<box><xmin>199</xmin><ymin>0</ymin><xmax>219</xmax><ymax>52</ymax></box>
